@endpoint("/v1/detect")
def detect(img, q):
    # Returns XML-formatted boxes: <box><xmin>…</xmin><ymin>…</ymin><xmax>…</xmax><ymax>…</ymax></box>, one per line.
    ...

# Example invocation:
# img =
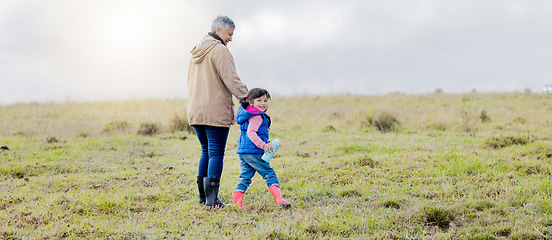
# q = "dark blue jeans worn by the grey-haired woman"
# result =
<box><xmin>193</xmin><ymin>125</ymin><xmax>230</xmax><ymax>178</ymax></box>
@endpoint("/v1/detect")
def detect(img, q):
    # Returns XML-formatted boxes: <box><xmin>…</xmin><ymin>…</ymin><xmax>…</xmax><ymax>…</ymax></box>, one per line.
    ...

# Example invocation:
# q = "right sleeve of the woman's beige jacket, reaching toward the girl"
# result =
<box><xmin>213</xmin><ymin>44</ymin><xmax>248</xmax><ymax>99</ymax></box>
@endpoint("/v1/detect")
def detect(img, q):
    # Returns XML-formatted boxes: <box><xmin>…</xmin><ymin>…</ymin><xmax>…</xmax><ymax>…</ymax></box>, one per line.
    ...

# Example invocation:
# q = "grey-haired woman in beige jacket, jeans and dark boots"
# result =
<box><xmin>187</xmin><ymin>16</ymin><xmax>248</xmax><ymax>208</ymax></box>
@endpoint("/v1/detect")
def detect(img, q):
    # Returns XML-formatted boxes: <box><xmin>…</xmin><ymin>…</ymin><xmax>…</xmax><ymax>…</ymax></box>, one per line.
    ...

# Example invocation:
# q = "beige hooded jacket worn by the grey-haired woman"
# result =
<box><xmin>187</xmin><ymin>35</ymin><xmax>248</xmax><ymax>127</ymax></box>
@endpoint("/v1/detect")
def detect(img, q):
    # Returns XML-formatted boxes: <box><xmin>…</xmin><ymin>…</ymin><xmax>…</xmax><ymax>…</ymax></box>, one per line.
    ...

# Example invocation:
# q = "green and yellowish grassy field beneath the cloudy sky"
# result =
<box><xmin>0</xmin><ymin>93</ymin><xmax>552</xmax><ymax>239</ymax></box>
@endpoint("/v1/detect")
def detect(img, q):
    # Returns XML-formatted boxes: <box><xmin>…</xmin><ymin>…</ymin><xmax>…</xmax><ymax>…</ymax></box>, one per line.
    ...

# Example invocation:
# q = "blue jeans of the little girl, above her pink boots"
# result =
<box><xmin>236</xmin><ymin>153</ymin><xmax>280</xmax><ymax>192</ymax></box>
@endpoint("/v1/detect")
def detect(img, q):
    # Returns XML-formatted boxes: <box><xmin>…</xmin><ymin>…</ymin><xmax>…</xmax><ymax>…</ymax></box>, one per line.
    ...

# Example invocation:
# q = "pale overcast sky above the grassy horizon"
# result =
<box><xmin>0</xmin><ymin>0</ymin><xmax>552</xmax><ymax>104</ymax></box>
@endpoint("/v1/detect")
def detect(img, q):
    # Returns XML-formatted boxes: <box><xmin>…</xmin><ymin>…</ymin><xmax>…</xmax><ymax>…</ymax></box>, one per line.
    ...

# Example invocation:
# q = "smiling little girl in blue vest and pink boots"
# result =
<box><xmin>232</xmin><ymin>88</ymin><xmax>291</xmax><ymax>208</ymax></box>
